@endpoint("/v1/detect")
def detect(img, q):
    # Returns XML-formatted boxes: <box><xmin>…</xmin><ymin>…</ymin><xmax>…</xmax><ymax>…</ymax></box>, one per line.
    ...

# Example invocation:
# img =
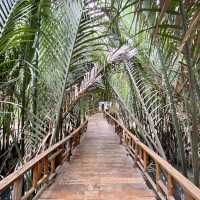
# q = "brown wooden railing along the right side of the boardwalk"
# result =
<box><xmin>105</xmin><ymin>112</ymin><xmax>200</xmax><ymax>200</ymax></box>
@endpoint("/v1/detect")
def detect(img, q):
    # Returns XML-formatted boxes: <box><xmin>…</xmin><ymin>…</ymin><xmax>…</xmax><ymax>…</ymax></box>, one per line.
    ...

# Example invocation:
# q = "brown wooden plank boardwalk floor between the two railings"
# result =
<box><xmin>40</xmin><ymin>114</ymin><xmax>155</xmax><ymax>200</ymax></box>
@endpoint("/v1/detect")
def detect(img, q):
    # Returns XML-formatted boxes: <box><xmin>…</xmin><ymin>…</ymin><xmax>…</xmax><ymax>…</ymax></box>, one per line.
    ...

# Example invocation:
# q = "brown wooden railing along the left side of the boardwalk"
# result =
<box><xmin>0</xmin><ymin>121</ymin><xmax>88</xmax><ymax>200</ymax></box>
